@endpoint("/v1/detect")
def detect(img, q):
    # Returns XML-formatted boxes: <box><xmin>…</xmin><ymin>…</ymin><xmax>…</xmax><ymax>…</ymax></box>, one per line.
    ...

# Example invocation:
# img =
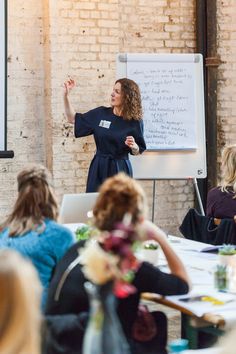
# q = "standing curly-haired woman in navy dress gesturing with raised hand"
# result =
<box><xmin>64</xmin><ymin>78</ymin><xmax>146</xmax><ymax>192</ymax></box>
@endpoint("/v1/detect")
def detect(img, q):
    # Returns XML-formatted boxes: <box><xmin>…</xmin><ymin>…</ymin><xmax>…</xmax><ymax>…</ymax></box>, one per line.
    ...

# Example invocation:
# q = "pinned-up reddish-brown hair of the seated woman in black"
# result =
<box><xmin>93</xmin><ymin>173</ymin><xmax>147</xmax><ymax>231</ymax></box>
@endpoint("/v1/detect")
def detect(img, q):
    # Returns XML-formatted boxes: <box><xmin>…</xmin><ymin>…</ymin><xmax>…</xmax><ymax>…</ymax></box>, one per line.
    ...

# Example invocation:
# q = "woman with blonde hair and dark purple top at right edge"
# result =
<box><xmin>206</xmin><ymin>144</ymin><xmax>236</xmax><ymax>219</ymax></box>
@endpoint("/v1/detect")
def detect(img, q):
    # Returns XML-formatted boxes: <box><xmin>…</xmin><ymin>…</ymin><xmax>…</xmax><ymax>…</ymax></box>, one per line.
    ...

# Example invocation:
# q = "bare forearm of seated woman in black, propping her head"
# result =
<box><xmin>142</xmin><ymin>220</ymin><xmax>191</xmax><ymax>287</ymax></box>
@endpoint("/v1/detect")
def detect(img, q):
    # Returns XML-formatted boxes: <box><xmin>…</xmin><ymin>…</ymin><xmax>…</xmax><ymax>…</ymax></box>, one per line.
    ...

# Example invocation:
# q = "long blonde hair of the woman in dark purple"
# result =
<box><xmin>221</xmin><ymin>144</ymin><xmax>236</xmax><ymax>198</ymax></box>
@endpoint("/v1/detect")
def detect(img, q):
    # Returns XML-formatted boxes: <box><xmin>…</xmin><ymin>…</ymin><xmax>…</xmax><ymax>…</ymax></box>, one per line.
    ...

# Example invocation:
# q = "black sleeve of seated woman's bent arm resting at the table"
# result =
<box><xmin>134</xmin><ymin>262</ymin><xmax>189</xmax><ymax>295</ymax></box>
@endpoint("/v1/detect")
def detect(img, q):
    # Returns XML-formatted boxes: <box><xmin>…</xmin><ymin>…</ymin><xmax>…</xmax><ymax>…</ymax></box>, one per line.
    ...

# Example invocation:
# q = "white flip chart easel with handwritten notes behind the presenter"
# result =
<box><xmin>116</xmin><ymin>53</ymin><xmax>207</xmax><ymax>215</ymax></box>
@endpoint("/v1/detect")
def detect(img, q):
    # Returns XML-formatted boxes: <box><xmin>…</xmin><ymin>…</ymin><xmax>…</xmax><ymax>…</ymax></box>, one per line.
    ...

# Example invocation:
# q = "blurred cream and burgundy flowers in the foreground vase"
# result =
<box><xmin>80</xmin><ymin>220</ymin><xmax>150</xmax><ymax>298</ymax></box>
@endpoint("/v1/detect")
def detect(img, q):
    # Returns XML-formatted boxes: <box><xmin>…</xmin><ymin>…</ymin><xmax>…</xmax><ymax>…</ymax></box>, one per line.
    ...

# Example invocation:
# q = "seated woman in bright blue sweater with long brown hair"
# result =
<box><xmin>0</xmin><ymin>165</ymin><xmax>74</xmax><ymax>304</ymax></box>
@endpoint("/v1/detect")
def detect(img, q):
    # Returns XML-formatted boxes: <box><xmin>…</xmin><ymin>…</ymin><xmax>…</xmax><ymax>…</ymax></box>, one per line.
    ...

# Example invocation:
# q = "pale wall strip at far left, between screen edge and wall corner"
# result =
<box><xmin>0</xmin><ymin>0</ymin><xmax>45</xmax><ymax>216</ymax></box>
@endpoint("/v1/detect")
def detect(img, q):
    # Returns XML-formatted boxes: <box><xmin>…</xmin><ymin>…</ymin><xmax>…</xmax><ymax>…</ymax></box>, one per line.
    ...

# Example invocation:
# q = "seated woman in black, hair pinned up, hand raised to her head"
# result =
<box><xmin>46</xmin><ymin>173</ymin><xmax>189</xmax><ymax>354</ymax></box>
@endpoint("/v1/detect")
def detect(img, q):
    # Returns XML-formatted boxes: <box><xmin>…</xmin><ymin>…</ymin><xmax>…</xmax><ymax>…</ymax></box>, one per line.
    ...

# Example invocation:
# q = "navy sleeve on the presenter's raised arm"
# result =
<box><xmin>74</xmin><ymin>109</ymin><xmax>96</xmax><ymax>138</ymax></box>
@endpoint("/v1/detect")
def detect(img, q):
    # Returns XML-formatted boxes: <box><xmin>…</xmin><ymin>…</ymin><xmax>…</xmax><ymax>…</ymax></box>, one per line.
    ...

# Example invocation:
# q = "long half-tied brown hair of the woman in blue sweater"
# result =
<box><xmin>1</xmin><ymin>165</ymin><xmax>58</xmax><ymax>236</ymax></box>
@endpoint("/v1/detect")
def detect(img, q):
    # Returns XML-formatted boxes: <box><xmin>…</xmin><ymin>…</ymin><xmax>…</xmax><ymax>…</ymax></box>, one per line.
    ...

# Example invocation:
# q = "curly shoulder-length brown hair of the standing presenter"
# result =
<box><xmin>115</xmin><ymin>78</ymin><xmax>143</xmax><ymax>120</ymax></box>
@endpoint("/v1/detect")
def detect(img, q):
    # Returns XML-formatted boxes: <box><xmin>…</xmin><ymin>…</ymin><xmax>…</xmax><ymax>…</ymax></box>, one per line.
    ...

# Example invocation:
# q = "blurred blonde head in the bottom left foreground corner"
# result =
<box><xmin>0</xmin><ymin>250</ymin><xmax>41</xmax><ymax>354</ymax></box>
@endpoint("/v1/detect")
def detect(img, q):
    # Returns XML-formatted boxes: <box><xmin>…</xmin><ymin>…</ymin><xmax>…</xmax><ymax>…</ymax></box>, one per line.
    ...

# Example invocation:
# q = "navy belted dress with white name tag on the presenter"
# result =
<box><xmin>75</xmin><ymin>107</ymin><xmax>146</xmax><ymax>192</ymax></box>
